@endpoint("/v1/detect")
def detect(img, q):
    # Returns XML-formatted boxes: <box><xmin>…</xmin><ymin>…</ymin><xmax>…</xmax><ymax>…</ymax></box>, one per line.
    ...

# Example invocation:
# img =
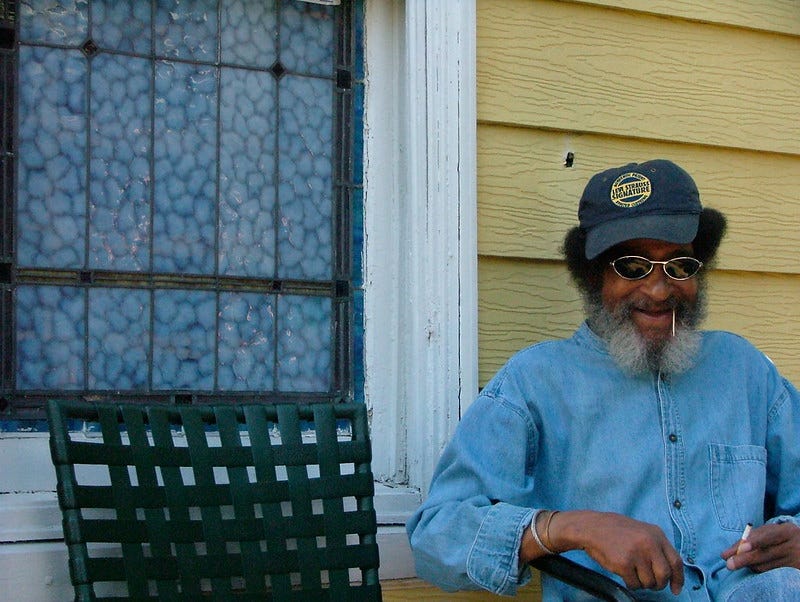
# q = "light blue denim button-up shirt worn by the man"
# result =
<box><xmin>407</xmin><ymin>324</ymin><xmax>800</xmax><ymax>600</ymax></box>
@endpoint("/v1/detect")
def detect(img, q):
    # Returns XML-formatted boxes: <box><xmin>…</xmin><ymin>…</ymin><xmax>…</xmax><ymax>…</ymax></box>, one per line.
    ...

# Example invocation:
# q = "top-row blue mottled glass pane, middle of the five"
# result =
<box><xmin>155</xmin><ymin>0</ymin><xmax>217</xmax><ymax>62</ymax></box>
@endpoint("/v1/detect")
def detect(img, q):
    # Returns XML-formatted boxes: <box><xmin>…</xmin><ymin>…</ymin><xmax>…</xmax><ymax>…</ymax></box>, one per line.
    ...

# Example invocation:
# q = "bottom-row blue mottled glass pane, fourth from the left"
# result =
<box><xmin>218</xmin><ymin>293</ymin><xmax>275</xmax><ymax>391</ymax></box>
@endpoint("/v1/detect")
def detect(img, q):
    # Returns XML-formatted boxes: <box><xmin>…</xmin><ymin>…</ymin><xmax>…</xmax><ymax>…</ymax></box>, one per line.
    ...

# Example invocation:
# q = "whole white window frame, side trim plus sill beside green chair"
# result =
<box><xmin>0</xmin><ymin>0</ymin><xmax>478</xmax><ymax>602</ymax></box>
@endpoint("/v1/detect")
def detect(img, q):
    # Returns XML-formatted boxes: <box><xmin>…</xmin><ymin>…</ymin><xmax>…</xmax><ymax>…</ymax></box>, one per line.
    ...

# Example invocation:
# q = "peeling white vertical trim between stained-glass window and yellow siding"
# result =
<box><xmin>364</xmin><ymin>0</ymin><xmax>478</xmax><ymax>494</ymax></box>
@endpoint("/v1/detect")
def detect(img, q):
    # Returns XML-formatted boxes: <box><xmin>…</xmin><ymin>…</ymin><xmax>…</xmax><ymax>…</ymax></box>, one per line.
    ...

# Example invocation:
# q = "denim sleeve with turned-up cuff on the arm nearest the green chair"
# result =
<box><xmin>407</xmin><ymin>394</ymin><xmax>536</xmax><ymax>595</ymax></box>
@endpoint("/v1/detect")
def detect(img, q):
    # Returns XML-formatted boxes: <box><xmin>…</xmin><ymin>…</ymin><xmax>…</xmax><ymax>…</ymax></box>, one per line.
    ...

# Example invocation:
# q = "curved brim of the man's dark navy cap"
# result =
<box><xmin>586</xmin><ymin>213</ymin><xmax>700</xmax><ymax>259</ymax></box>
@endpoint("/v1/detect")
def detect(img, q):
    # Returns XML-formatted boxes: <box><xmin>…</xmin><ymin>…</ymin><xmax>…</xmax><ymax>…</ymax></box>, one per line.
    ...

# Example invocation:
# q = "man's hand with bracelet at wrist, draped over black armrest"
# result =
<box><xmin>528</xmin><ymin>510</ymin><xmax>684</xmax><ymax>595</ymax></box>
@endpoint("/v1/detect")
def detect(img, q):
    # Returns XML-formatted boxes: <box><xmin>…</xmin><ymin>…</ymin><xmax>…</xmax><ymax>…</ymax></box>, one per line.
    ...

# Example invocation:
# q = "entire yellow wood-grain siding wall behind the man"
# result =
<box><xmin>477</xmin><ymin>0</ymin><xmax>800</xmax><ymax>384</ymax></box>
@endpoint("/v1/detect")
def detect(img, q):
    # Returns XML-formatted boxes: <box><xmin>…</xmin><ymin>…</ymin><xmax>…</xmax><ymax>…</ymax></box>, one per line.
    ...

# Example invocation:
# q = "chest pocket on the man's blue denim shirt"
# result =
<box><xmin>708</xmin><ymin>443</ymin><xmax>767</xmax><ymax>531</ymax></box>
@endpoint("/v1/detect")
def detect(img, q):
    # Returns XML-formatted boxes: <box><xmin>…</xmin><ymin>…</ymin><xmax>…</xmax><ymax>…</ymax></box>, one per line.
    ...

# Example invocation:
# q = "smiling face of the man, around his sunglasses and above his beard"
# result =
<box><xmin>601</xmin><ymin>238</ymin><xmax>698</xmax><ymax>346</ymax></box>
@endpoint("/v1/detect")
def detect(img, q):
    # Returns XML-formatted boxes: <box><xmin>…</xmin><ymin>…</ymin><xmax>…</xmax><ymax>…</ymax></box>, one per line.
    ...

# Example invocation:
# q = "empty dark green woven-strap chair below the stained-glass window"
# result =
<box><xmin>47</xmin><ymin>401</ymin><xmax>381</xmax><ymax>602</ymax></box>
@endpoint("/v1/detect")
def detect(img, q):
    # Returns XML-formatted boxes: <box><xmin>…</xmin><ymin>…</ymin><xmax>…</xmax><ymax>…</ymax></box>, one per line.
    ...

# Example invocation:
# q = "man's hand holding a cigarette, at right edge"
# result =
<box><xmin>722</xmin><ymin>523</ymin><xmax>800</xmax><ymax>573</ymax></box>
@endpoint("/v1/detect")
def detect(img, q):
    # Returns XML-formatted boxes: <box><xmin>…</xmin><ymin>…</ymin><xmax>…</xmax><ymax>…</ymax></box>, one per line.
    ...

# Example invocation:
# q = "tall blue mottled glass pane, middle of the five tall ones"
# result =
<box><xmin>153</xmin><ymin>62</ymin><xmax>217</xmax><ymax>274</ymax></box>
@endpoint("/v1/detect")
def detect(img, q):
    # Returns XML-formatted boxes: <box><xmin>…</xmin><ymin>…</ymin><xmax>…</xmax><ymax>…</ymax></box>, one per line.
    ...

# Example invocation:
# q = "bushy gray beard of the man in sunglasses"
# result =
<box><xmin>585</xmin><ymin>283</ymin><xmax>707</xmax><ymax>375</ymax></box>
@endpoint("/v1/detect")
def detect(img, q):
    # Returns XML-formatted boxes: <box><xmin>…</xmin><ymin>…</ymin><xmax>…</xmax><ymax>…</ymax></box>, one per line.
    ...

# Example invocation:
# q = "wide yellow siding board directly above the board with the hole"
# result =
<box><xmin>478</xmin><ymin>0</ymin><xmax>800</xmax><ymax>153</ymax></box>
